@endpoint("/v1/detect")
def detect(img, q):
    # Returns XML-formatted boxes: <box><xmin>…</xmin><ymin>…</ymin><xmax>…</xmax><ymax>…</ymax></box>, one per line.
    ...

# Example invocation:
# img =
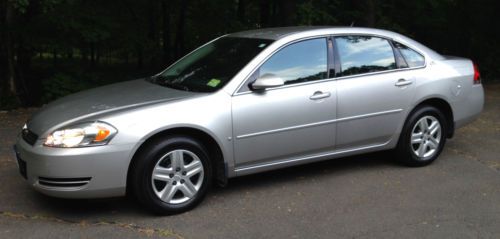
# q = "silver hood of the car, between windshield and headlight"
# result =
<box><xmin>28</xmin><ymin>79</ymin><xmax>198</xmax><ymax>136</ymax></box>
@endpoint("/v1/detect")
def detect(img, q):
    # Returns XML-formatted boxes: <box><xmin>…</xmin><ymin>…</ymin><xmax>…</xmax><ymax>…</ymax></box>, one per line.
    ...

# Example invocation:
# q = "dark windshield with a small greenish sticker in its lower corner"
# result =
<box><xmin>150</xmin><ymin>37</ymin><xmax>272</xmax><ymax>92</ymax></box>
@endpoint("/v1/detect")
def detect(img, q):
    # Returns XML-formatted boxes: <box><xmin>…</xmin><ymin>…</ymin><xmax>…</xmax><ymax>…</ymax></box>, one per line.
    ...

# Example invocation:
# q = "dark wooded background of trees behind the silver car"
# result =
<box><xmin>0</xmin><ymin>0</ymin><xmax>500</xmax><ymax>109</ymax></box>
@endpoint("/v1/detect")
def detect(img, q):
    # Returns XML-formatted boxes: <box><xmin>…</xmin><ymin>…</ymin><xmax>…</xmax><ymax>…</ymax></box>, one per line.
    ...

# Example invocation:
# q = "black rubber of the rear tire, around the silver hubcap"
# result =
<box><xmin>395</xmin><ymin>105</ymin><xmax>448</xmax><ymax>167</ymax></box>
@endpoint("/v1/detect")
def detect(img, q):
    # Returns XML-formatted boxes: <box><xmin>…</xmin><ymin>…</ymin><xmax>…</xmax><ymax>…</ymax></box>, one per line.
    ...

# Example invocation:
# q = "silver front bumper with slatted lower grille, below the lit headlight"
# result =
<box><xmin>14</xmin><ymin>138</ymin><xmax>133</xmax><ymax>198</ymax></box>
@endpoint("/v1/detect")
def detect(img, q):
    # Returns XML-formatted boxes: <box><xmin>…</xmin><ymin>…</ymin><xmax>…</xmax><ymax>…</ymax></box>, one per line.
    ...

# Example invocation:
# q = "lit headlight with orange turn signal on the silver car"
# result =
<box><xmin>44</xmin><ymin>122</ymin><xmax>117</xmax><ymax>148</ymax></box>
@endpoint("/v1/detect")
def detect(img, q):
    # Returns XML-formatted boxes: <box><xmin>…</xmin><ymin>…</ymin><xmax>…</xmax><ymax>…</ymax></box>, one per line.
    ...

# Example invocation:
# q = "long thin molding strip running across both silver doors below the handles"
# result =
<box><xmin>236</xmin><ymin>109</ymin><xmax>403</xmax><ymax>139</ymax></box>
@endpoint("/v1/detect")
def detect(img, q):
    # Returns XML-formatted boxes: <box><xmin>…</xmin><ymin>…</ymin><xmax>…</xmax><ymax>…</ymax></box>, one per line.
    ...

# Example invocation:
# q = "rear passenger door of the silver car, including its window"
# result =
<box><xmin>334</xmin><ymin>36</ymin><xmax>418</xmax><ymax>150</ymax></box>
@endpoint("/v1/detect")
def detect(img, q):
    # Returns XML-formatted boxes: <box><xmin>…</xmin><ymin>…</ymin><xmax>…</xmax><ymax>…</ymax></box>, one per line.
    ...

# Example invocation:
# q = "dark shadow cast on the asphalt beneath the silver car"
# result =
<box><xmin>29</xmin><ymin>152</ymin><xmax>401</xmax><ymax>218</ymax></box>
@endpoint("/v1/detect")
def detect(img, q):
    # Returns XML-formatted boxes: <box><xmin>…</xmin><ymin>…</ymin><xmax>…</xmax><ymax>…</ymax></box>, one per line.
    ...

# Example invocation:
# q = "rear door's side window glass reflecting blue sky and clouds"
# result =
<box><xmin>335</xmin><ymin>36</ymin><xmax>396</xmax><ymax>76</ymax></box>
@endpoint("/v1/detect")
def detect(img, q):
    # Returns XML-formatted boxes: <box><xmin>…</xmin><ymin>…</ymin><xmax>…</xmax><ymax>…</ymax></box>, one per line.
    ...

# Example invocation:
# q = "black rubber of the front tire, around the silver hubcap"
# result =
<box><xmin>129</xmin><ymin>136</ymin><xmax>212</xmax><ymax>215</ymax></box>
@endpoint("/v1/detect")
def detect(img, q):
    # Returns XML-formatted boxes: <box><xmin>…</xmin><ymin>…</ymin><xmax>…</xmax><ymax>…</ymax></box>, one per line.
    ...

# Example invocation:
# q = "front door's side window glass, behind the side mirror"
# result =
<box><xmin>259</xmin><ymin>38</ymin><xmax>327</xmax><ymax>85</ymax></box>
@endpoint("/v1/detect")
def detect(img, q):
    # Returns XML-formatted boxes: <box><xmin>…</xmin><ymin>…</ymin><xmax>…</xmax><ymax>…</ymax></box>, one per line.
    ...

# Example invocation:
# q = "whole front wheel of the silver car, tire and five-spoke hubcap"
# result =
<box><xmin>129</xmin><ymin>136</ymin><xmax>212</xmax><ymax>215</ymax></box>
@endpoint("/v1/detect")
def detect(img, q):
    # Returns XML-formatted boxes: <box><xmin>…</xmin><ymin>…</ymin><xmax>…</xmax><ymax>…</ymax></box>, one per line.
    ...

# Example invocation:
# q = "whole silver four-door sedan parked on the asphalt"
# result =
<box><xmin>15</xmin><ymin>27</ymin><xmax>484</xmax><ymax>214</ymax></box>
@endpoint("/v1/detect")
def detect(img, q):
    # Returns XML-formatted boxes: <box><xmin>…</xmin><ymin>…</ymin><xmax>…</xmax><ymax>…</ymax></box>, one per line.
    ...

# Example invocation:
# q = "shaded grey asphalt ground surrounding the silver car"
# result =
<box><xmin>0</xmin><ymin>84</ymin><xmax>500</xmax><ymax>238</ymax></box>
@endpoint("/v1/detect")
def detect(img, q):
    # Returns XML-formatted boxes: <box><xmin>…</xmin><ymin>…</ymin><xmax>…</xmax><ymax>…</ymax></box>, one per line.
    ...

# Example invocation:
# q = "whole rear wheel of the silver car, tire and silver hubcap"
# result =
<box><xmin>396</xmin><ymin>105</ymin><xmax>448</xmax><ymax>167</ymax></box>
